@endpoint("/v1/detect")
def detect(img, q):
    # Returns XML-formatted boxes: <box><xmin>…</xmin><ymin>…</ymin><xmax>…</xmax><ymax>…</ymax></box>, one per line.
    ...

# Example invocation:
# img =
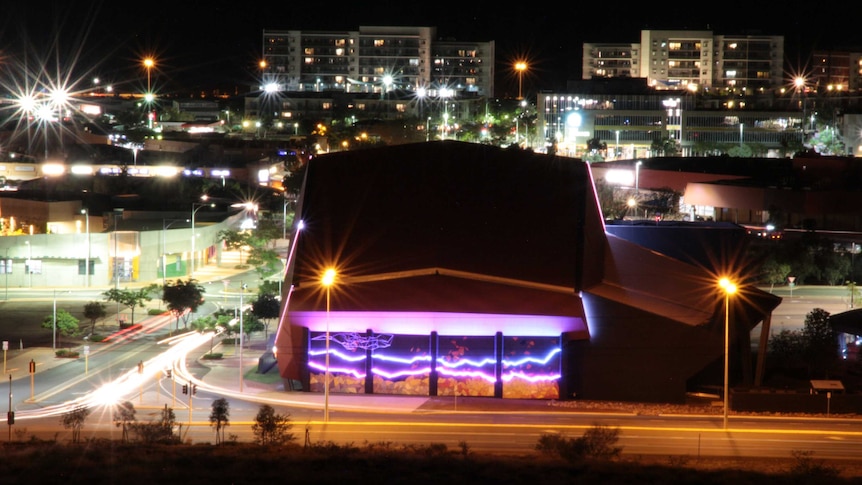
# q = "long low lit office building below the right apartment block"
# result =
<box><xmin>536</xmin><ymin>87</ymin><xmax>804</xmax><ymax>159</ymax></box>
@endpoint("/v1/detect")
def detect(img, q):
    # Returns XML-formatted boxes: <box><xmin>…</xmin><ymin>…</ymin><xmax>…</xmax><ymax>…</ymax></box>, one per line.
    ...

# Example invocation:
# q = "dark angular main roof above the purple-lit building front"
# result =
<box><xmin>293</xmin><ymin>141</ymin><xmax>600</xmax><ymax>294</ymax></box>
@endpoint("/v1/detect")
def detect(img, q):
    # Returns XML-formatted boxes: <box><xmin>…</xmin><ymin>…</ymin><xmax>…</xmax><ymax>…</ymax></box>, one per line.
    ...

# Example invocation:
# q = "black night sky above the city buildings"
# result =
<box><xmin>0</xmin><ymin>0</ymin><xmax>862</xmax><ymax>96</ymax></box>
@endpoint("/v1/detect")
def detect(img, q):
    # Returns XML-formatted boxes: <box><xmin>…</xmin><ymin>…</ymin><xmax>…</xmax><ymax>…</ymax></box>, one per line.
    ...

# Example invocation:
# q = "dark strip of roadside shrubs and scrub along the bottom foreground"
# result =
<box><xmin>0</xmin><ymin>399</ymin><xmax>862</xmax><ymax>485</ymax></box>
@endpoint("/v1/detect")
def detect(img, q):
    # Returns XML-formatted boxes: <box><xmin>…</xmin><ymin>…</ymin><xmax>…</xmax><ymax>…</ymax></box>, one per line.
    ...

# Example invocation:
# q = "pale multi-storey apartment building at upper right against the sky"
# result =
<box><xmin>583</xmin><ymin>30</ymin><xmax>784</xmax><ymax>90</ymax></box>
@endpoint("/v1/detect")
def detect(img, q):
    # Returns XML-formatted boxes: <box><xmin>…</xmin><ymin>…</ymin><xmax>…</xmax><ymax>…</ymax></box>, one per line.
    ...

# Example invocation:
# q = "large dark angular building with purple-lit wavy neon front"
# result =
<box><xmin>276</xmin><ymin>142</ymin><xmax>780</xmax><ymax>402</ymax></box>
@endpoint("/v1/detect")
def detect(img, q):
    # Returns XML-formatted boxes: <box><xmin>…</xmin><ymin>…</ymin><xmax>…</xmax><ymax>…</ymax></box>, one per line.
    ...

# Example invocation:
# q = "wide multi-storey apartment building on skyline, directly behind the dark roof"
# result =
<box><xmin>261</xmin><ymin>26</ymin><xmax>495</xmax><ymax>96</ymax></box>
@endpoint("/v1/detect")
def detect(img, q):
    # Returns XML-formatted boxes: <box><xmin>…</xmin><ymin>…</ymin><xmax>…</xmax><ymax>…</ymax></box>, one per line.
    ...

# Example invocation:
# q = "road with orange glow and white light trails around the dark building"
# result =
<box><xmin>0</xmin><ymin>280</ymin><xmax>862</xmax><ymax>459</ymax></box>
